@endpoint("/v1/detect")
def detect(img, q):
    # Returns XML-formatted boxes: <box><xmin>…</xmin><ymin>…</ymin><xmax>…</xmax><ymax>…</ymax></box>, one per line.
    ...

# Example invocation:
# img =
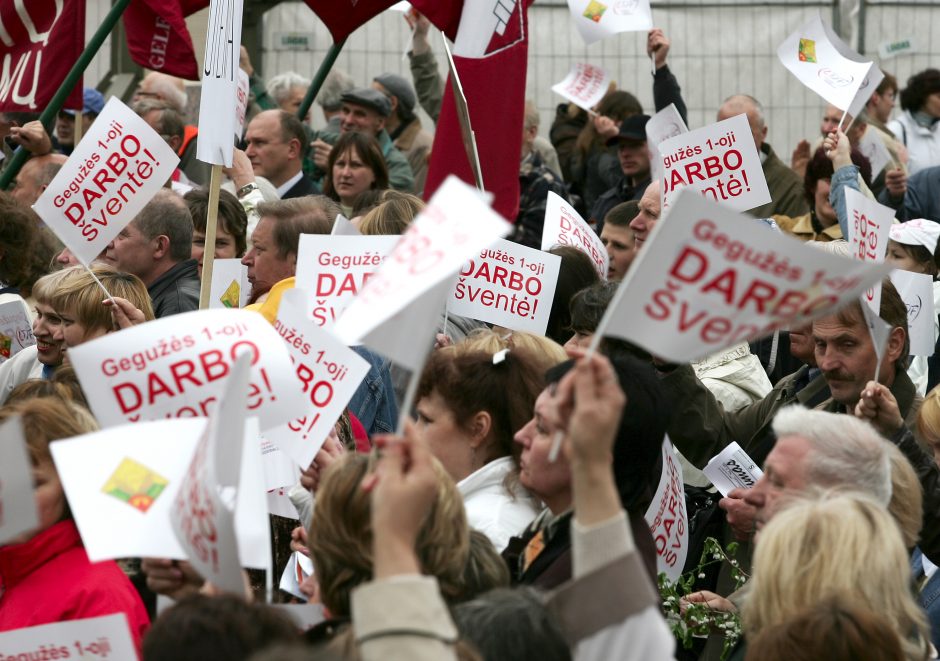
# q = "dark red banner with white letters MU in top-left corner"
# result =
<box><xmin>0</xmin><ymin>0</ymin><xmax>85</xmax><ymax>113</ymax></box>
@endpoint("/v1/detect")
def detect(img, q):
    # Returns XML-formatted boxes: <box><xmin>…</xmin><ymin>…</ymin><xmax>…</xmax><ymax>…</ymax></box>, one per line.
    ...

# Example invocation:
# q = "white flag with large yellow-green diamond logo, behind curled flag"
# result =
<box><xmin>50</xmin><ymin>418</ymin><xmax>268</xmax><ymax>569</ymax></box>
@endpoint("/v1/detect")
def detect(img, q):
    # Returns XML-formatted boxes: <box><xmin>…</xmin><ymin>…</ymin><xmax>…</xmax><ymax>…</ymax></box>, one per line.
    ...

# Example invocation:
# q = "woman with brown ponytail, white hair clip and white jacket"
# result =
<box><xmin>416</xmin><ymin>343</ymin><xmax>542</xmax><ymax>551</ymax></box>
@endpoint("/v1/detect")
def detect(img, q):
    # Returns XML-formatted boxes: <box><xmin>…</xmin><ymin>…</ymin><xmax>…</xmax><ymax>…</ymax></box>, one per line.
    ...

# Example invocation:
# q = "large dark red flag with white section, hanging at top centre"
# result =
<box><xmin>411</xmin><ymin>0</ymin><xmax>531</xmax><ymax>219</ymax></box>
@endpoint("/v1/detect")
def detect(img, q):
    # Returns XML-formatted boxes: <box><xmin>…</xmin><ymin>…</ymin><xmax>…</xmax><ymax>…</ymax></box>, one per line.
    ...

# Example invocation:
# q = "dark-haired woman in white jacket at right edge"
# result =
<box><xmin>888</xmin><ymin>69</ymin><xmax>940</xmax><ymax>175</ymax></box>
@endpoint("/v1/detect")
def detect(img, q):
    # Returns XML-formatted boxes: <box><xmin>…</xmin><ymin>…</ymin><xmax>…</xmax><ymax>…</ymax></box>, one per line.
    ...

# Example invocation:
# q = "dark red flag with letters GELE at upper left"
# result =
<box><xmin>124</xmin><ymin>0</ymin><xmax>209</xmax><ymax>80</ymax></box>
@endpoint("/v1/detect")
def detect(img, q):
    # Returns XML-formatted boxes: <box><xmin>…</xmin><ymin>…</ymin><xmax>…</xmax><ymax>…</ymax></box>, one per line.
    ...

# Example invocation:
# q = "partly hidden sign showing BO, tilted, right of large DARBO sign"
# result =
<box><xmin>265</xmin><ymin>289</ymin><xmax>369</xmax><ymax>466</ymax></box>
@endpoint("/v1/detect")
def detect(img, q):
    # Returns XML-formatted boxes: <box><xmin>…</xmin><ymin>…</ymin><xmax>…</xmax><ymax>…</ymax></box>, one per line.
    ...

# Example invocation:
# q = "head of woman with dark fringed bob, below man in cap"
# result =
<box><xmin>323</xmin><ymin>131</ymin><xmax>388</xmax><ymax>218</ymax></box>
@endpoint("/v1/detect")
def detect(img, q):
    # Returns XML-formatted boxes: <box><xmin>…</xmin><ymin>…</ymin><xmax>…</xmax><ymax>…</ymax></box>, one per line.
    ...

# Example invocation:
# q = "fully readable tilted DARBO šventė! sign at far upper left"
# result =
<box><xmin>33</xmin><ymin>96</ymin><xmax>179</xmax><ymax>265</ymax></box>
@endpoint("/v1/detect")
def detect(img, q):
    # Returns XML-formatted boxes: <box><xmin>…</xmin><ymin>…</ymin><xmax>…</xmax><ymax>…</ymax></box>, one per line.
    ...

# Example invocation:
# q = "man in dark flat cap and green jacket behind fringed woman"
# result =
<box><xmin>311</xmin><ymin>87</ymin><xmax>414</xmax><ymax>193</ymax></box>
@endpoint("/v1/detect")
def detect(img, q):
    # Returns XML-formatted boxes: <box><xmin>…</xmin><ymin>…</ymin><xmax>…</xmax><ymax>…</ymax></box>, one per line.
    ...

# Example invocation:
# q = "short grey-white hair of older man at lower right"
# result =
<box><xmin>773</xmin><ymin>406</ymin><xmax>891</xmax><ymax>507</ymax></box>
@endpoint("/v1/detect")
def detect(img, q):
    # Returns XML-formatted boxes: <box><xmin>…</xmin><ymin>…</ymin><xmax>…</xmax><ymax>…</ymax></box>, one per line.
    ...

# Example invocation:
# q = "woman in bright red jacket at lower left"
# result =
<box><xmin>0</xmin><ymin>397</ymin><xmax>150</xmax><ymax>650</ymax></box>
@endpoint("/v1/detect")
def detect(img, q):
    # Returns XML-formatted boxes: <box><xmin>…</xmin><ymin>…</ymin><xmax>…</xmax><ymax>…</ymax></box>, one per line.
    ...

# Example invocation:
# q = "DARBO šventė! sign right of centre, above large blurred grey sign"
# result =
<box><xmin>659</xmin><ymin>113</ymin><xmax>770</xmax><ymax>211</ymax></box>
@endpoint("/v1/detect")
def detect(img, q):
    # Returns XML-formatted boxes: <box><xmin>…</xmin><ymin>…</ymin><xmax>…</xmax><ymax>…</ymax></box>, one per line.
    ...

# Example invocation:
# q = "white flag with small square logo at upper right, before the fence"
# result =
<box><xmin>777</xmin><ymin>13</ymin><xmax>883</xmax><ymax>117</ymax></box>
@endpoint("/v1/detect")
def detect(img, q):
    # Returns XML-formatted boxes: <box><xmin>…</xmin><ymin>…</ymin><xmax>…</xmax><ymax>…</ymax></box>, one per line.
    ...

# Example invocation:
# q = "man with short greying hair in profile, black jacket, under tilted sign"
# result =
<box><xmin>104</xmin><ymin>189</ymin><xmax>199</xmax><ymax>319</ymax></box>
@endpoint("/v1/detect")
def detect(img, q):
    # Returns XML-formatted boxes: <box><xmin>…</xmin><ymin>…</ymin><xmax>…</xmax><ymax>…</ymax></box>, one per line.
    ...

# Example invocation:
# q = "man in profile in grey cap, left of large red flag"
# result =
<box><xmin>372</xmin><ymin>73</ymin><xmax>434</xmax><ymax>195</ymax></box>
